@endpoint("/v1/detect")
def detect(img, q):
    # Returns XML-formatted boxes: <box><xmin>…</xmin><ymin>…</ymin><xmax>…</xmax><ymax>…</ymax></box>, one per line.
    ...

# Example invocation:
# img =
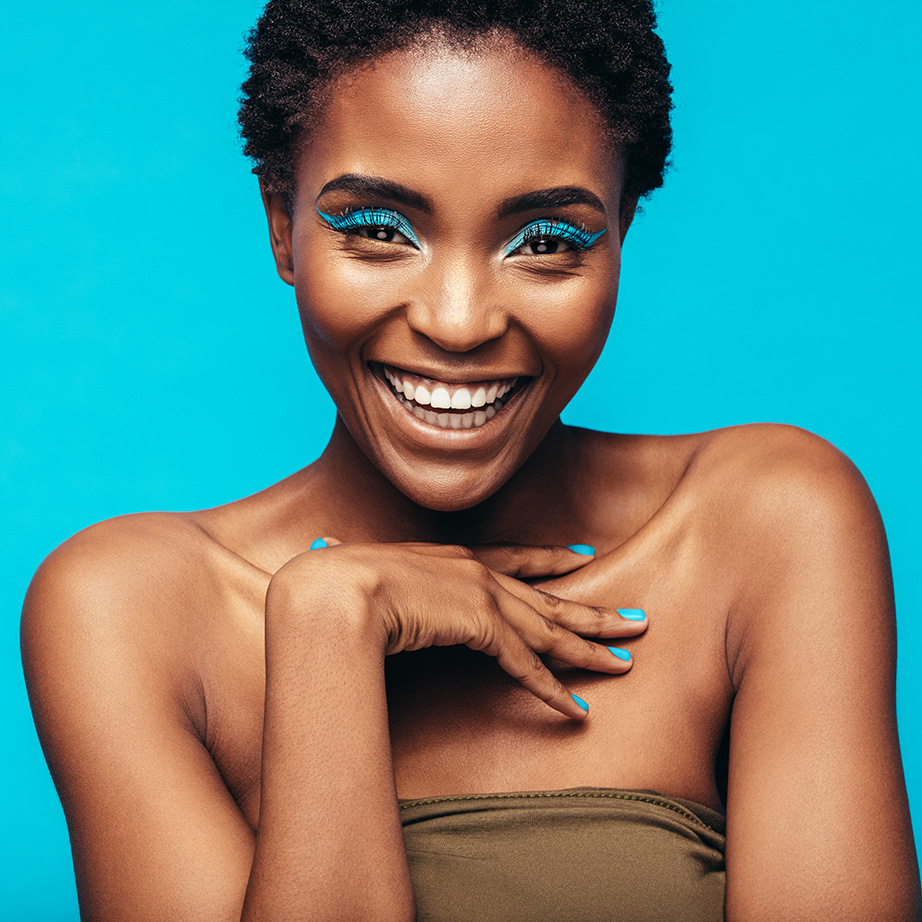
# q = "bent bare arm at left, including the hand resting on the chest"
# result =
<box><xmin>23</xmin><ymin>526</ymin><xmax>639</xmax><ymax>922</ymax></box>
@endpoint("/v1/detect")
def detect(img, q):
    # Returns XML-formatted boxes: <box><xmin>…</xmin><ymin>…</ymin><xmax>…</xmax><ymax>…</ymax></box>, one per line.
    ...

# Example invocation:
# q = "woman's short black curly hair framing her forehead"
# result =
<box><xmin>239</xmin><ymin>0</ymin><xmax>672</xmax><ymax>205</ymax></box>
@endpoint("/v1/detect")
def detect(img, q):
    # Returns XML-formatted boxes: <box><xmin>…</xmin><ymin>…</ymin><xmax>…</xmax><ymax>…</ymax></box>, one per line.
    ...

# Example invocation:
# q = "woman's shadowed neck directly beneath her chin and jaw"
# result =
<box><xmin>304</xmin><ymin>418</ymin><xmax>581</xmax><ymax>544</ymax></box>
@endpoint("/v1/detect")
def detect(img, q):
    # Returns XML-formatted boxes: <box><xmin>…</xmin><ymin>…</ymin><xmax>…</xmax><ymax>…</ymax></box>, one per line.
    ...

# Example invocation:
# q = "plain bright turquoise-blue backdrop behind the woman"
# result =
<box><xmin>0</xmin><ymin>0</ymin><xmax>922</xmax><ymax>922</ymax></box>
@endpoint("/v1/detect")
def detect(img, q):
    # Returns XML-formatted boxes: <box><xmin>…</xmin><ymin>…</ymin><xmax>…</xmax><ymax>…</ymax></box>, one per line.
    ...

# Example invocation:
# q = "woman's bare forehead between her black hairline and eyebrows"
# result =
<box><xmin>297</xmin><ymin>42</ymin><xmax>622</xmax><ymax>210</ymax></box>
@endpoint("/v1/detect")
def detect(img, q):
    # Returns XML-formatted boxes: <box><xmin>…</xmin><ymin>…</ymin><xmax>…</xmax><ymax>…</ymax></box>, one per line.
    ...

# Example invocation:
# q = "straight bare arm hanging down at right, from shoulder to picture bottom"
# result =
<box><xmin>726</xmin><ymin>430</ymin><xmax>919</xmax><ymax>922</ymax></box>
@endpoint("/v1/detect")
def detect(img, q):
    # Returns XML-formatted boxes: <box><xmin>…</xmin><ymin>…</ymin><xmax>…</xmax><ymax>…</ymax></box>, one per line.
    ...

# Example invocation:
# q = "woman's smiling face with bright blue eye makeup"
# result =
<box><xmin>267</xmin><ymin>37</ymin><xmax>632</xmax><ymax>510</ymax></box>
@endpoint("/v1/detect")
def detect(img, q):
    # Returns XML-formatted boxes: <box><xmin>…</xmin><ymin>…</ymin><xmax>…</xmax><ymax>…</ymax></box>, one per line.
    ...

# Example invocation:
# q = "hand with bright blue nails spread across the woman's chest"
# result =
<box><xmin>298</xmin><ymin>538</ymin><xmax>647</xmax><ymax>719</ymax></box>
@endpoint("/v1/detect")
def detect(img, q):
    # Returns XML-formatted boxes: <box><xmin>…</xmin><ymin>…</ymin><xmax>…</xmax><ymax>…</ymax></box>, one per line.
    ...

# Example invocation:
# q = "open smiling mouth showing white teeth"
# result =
<box><xmin>380</xmin><ymin>365</ymin><xmax>520</xmax><ymax>429</ymax></box>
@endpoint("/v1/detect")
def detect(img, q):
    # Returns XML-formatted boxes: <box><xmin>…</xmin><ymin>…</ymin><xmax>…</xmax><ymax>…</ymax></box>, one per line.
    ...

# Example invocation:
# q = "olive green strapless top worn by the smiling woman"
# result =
<box><xmin>400</xmin><ymin>788</ymin><xmax>726</xmax><ymax>922</ymax></box>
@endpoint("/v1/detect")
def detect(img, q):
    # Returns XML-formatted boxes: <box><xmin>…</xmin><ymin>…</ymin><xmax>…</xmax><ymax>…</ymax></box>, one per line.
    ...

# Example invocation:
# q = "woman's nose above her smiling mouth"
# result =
<box><xmin>406</xmin><ymin>253</ymin><xmax>509</xmax><ymax>352</ymax></box>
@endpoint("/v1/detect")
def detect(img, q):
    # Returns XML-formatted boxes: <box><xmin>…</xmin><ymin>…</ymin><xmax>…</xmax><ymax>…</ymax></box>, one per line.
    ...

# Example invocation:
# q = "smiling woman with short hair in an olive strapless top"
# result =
<box><xmin>18</xmin><ymin>2</ymin><xmax>919</xmax><ymax>920</ymax></box>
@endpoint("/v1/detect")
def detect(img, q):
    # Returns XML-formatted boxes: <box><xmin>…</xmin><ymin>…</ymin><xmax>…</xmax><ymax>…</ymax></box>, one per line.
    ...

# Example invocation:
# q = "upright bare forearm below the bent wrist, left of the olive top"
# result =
<box><xmin>243</xmin><ymin>552</ymin><xmax>415</xmax><ymax>922</ymax></box>
